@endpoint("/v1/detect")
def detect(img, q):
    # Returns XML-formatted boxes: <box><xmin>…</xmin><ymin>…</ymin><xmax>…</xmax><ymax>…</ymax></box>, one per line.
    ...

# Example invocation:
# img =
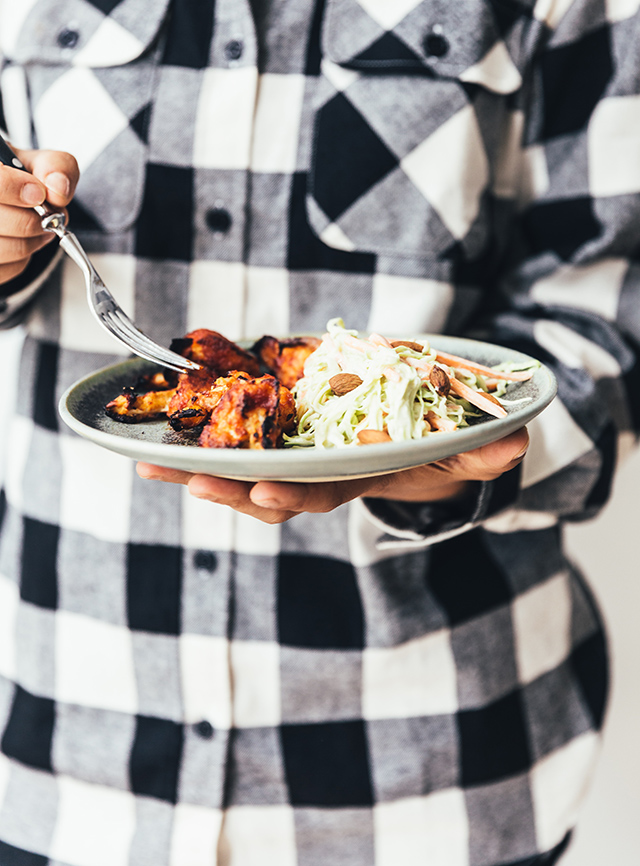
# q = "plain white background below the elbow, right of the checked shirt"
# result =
<box><xmin>562</xmin><ymin>452</ymin><xmax>640</xmax><ymax>866</ymax></box>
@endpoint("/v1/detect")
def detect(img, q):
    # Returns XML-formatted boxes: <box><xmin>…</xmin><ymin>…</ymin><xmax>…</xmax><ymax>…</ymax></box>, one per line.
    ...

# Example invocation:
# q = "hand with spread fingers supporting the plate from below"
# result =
<box><xmin>137</xmin><ymin>427</ymin><xmax>529</xmax><ymax>523</ymax></box>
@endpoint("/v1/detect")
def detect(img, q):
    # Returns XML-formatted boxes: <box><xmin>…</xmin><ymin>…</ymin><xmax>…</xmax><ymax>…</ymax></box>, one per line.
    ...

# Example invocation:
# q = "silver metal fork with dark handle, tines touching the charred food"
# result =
<box><xmin>0</xmin><ymin>135</ymin><xmax>200</xmax><ymax>372</ymax></box>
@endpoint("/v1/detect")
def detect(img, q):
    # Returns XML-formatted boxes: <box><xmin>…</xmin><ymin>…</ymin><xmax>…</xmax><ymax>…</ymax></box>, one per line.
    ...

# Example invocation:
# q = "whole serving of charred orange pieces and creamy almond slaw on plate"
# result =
<box><xmin>105</xmin><ymin>319</ymin><xmax>538</xmax><ymax>449</ymax></box>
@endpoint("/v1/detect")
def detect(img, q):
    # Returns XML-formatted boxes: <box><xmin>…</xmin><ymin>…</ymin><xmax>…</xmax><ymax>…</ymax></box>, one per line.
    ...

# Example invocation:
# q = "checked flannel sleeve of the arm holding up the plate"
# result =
<box><xmin>365</xmin><ymin>0</ymin><xmax>640</xmax><ymax>546</ymax></box>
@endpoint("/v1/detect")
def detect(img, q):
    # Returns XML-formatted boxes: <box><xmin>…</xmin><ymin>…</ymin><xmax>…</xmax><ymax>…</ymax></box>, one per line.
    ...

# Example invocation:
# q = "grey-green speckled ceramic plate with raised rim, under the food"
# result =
<box><xmin>59</xmin><ymin>335</ymin><xmax>557</xmax><ymax>481</ymax></box>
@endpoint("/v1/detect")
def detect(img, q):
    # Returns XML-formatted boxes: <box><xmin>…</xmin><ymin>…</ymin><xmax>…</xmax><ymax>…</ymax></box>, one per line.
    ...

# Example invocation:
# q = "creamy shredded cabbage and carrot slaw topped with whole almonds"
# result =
<box><xmin>285</xmin><ymin>319</ymin><xmax>534</xmax><ymax>448</ymax></box>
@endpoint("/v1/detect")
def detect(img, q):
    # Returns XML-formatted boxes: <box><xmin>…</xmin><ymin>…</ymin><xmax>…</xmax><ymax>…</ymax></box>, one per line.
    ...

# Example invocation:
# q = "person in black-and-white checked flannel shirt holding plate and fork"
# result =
<box><xmin>0</xmin><ymin>0</ymin><xmax>640</xmax><ymax>866</ymax></box>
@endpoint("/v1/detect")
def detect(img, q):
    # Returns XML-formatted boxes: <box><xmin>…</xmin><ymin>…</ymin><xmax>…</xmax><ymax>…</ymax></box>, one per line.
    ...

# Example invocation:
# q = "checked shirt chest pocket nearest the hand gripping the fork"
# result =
<box><xmin>0</xmin><ymin>0</ymin><xmax>169</xmax><ymax>232</ymax></box>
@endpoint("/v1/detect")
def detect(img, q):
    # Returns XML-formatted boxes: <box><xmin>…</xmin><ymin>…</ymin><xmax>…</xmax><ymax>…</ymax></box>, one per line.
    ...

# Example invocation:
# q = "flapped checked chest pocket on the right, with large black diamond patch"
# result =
<box><xmin>307</xmin><ymin>0</ymin><xmax>528</xmax><ymax>258</ymax></box>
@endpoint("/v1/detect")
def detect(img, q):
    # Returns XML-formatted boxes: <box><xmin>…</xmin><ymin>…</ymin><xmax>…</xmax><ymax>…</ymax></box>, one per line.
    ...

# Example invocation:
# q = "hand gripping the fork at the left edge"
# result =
<box><xmin>0</xmin><ymin>148</ymin><xmax>80</xmax><ymax>285</ymax></box>
